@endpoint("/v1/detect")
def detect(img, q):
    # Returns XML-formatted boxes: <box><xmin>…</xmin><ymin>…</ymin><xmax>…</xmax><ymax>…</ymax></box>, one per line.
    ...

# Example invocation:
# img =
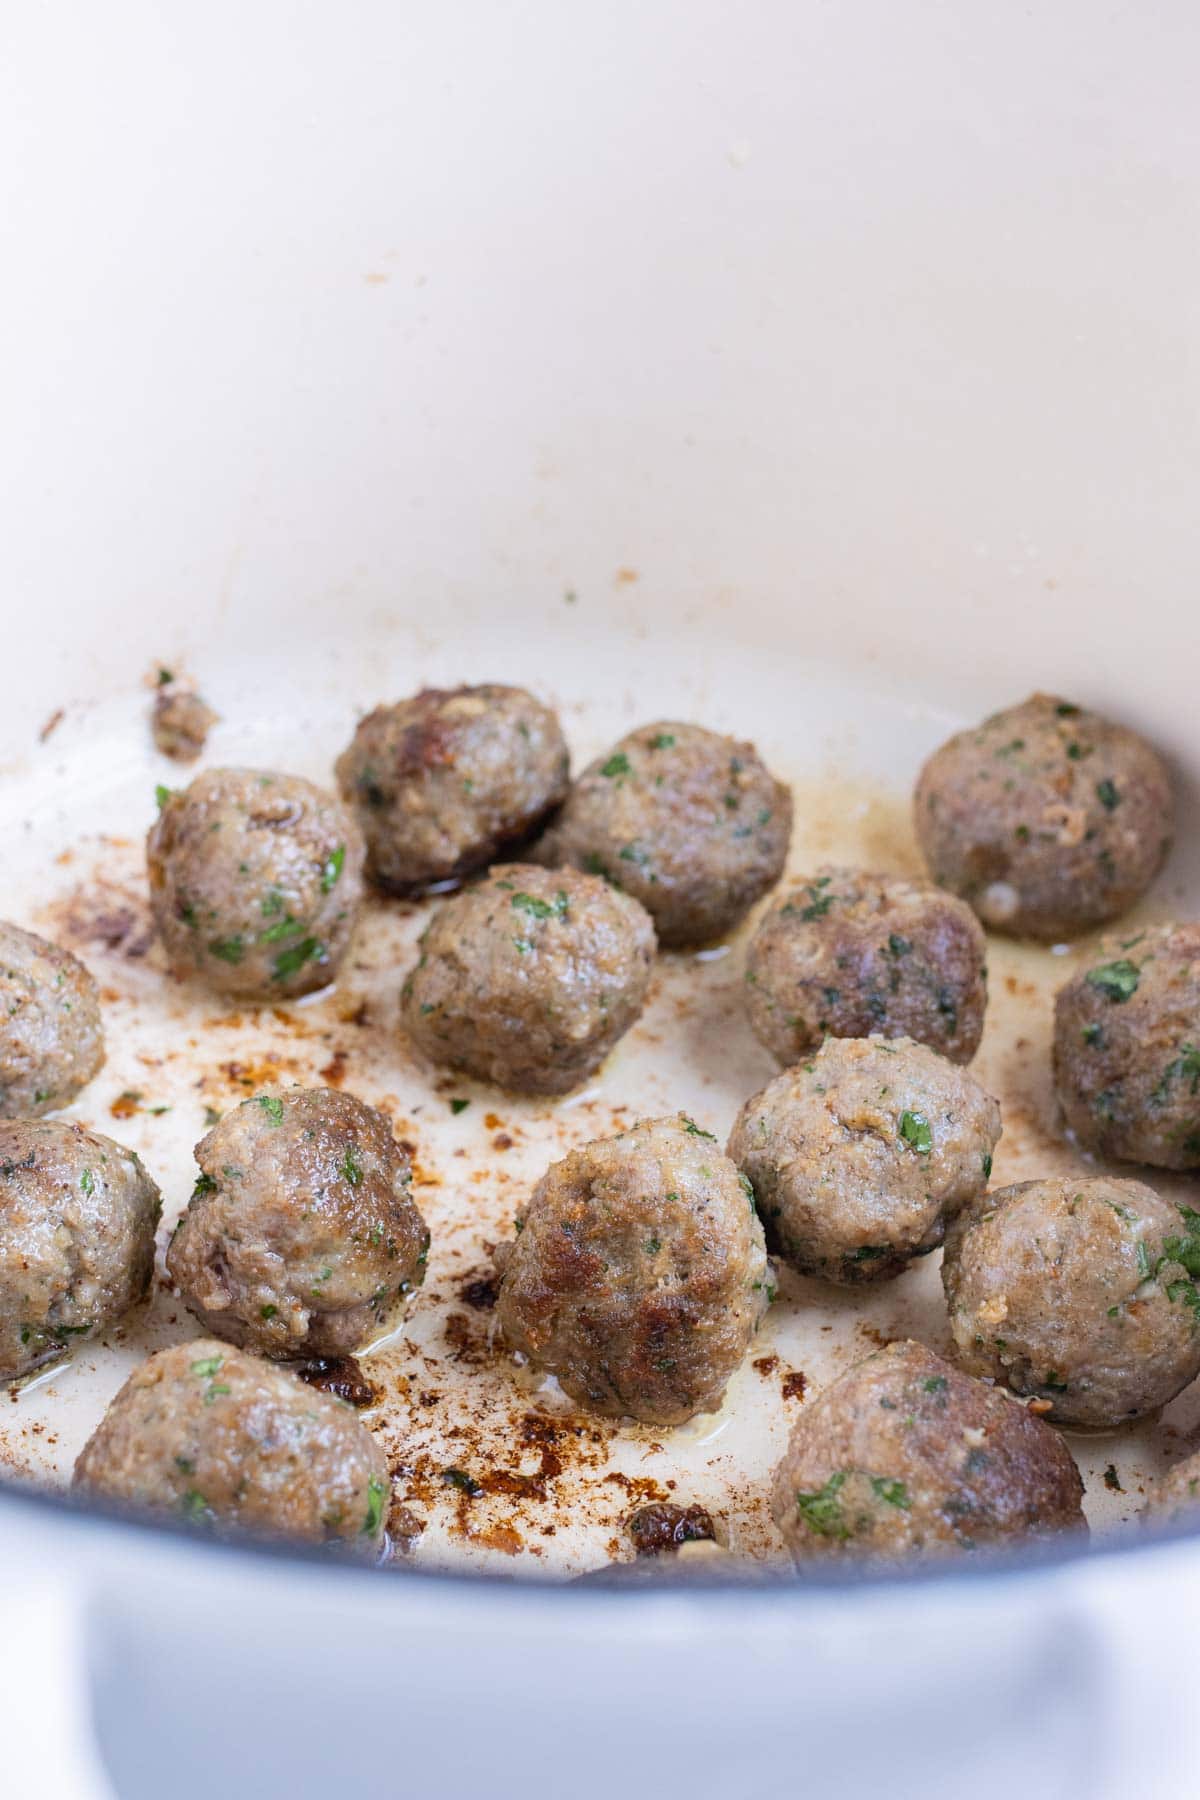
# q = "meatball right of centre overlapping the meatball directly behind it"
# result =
<box><xmin>729</xmin><ymin>1037</ymin><xmax>1000</xmax><ymax>1283</ymax></box>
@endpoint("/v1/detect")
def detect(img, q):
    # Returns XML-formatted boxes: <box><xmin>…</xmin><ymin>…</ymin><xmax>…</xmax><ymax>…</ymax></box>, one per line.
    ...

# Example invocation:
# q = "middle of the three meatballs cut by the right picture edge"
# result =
<box><xmin>943</xmin><ymin>1175</ymin><xmax>1200</xmax><ymax>1429</ymax></box>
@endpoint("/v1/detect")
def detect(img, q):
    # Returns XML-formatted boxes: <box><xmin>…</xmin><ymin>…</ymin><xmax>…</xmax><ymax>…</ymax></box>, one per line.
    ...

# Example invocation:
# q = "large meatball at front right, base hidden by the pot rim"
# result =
<box><xmin>772</xmin><ymin>1341</ymin><xmax>1083</xmax><ymax>1562</ymax></box>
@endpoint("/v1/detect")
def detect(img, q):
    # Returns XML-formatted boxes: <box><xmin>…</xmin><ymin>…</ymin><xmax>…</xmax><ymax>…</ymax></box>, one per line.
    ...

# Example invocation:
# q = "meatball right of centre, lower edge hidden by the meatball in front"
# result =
<box><xmin>747</xmin><ymin>868</ymin><xmax>988</xmax><ymax>1062</ymax></box>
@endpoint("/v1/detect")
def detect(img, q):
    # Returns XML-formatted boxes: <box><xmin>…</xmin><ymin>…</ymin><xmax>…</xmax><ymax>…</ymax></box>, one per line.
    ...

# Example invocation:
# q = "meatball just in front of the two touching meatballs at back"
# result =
<box><xmin>401</xmin><ymin>862</ymin><xmax>655</xmax><ymax>1094</ymax></box>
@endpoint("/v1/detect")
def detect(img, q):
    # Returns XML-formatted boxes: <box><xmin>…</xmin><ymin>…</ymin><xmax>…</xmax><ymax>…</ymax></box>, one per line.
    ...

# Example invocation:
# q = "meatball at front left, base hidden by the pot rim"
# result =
<box><xmin>74</xmin><ymin>1337</ymin><xmax>390</xmax><ymax>1550</ymax></box>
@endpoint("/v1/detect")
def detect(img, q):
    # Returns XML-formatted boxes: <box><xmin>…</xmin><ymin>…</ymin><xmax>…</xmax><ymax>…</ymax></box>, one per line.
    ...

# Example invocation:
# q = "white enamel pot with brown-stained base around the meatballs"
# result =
<box><xmin>0</xmin><ymin>0</ymin><xmax>1200</xmax><ymax>1796</ymax></box>
